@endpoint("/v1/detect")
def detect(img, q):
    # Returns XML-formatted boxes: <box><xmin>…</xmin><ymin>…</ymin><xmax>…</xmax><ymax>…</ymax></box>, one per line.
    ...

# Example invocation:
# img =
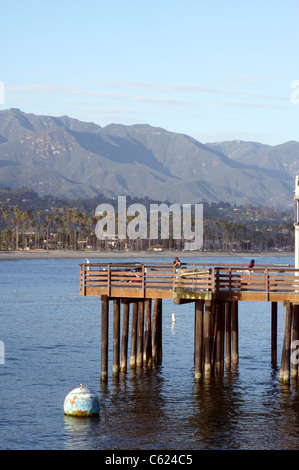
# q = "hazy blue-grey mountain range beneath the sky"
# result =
<box><xmin>0</xmin><ymin>109</ymin><xmax>299</xmax><ymax>208</ymax></box>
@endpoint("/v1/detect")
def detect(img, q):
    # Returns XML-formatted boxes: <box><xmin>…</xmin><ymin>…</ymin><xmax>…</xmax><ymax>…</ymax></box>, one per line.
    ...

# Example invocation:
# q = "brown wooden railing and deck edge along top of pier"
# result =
<box><xmin>80</xmin><ymin>263</ymin><xmax>299</xmax><ymax>300</ymax></box>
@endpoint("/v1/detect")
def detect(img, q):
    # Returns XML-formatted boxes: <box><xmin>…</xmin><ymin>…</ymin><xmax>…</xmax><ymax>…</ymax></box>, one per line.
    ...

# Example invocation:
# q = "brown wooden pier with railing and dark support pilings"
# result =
<box><xmin>80</xmin><ymin>263</ymin><xmax>299</xmax><ymax>383</ymax></box>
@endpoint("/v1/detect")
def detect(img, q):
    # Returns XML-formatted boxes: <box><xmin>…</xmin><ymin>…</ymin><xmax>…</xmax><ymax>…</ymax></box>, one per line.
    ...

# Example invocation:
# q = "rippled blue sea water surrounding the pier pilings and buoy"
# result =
<box><xmin>0</xmin><ymin>253</ymin><xmax>299</xmax><ymax>450</ymax></box>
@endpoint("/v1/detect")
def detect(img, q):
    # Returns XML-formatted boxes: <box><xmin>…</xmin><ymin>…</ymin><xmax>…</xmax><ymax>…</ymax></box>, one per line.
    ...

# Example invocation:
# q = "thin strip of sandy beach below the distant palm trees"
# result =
<box><xmin>0</xmin><ymin>250</ymin><xmax>294</xmax><ymax>261</ymax></box>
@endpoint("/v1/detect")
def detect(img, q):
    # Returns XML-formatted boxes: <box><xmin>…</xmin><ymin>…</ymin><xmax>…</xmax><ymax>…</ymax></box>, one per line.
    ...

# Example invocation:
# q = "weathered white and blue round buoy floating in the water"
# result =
<box><xmin>63</xmin><ymin>384</ymin><xmax>100</xmax><ymax>416</ymax></box>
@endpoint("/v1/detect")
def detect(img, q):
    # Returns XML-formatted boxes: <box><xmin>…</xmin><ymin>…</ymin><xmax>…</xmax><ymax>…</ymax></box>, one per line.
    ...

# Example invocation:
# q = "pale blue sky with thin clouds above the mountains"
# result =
<box><xmin>0</xmin><ymin>0</ymin><xmax>299</xmax><ymax>145</ymax></box>
